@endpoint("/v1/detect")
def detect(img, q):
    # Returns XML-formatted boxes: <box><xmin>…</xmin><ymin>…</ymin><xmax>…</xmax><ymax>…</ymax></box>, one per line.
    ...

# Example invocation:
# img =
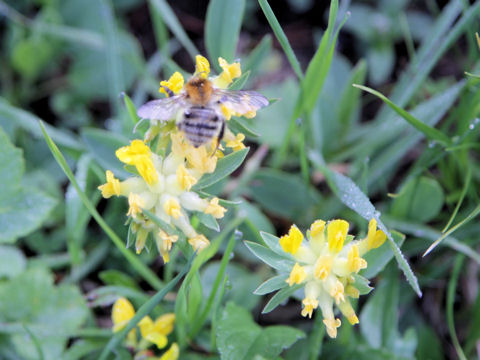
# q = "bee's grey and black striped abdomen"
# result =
<box><xmin>178</xmin><ymin>106</ymin><xmax>222</xmax><ymax>147</ymax></box>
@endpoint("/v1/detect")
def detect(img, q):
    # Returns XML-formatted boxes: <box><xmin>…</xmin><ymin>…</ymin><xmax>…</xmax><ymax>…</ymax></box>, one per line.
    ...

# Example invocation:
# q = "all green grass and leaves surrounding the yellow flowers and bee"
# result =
<box><xmin>0</xmin><ymin>0</ymin><xmax>480</xmax><ymax>360</ymax></box>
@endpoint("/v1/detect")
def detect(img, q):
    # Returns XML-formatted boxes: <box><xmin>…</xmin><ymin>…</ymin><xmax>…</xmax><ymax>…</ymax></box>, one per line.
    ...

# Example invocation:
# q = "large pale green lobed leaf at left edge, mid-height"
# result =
<box><xmin>0</xmin><ymin>127</ymin><xmax>56</xmax><ymax>243</ymax></box>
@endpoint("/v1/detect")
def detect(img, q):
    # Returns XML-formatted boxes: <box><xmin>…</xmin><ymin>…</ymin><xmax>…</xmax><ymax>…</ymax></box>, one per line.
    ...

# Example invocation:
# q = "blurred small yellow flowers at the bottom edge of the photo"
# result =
<box><xmin>112</xmin><ymin>297</ymin><xmax>179</xmax><ymax>360</ymax></box>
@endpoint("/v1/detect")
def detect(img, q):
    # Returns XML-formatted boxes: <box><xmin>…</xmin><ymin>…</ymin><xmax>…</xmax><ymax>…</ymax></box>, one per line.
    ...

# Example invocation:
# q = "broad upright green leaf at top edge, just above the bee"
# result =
<box><xmin>205</xmin><ymin>0</ymin><xmax>245</xmax><ymax>69</ymax></box>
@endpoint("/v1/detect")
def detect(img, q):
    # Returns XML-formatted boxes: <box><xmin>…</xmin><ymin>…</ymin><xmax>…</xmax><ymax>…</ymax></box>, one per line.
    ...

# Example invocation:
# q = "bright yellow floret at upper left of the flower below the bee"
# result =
<box><xmin>115</xmin><ymin>140</ymin><xmax>158</xmax><ymax>185</ymax></box>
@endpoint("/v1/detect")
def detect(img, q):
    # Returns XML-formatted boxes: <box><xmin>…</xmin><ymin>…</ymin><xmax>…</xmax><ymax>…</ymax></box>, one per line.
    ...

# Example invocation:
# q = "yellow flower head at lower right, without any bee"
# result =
<box><xmin>280</xmin><ymin>219</ymin><xmax>386</xmax><ymax>338</ymax></box>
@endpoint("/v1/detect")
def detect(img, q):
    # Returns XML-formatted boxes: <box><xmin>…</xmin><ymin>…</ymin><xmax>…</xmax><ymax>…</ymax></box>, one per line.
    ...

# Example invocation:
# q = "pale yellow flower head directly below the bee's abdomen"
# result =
<box><xmin>99</xmin><ymin>132</ymin><xmax>226</xmax><ymax>262</ymax></box>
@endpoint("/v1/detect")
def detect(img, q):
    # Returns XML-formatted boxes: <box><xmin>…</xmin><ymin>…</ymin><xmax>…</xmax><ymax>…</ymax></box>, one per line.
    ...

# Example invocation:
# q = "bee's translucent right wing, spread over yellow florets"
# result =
<box><xmin>215</xmin><ymin>89</ymin><xmax>269</xmax><ymax>114</ymax></box>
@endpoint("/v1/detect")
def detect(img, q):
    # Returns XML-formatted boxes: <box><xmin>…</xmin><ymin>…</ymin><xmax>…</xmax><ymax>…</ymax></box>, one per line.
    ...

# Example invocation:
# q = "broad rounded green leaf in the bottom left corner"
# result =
<box><xmin>0</xmin><ymin>268</ymin><xmax>88</xmax><ymax>360</ymax></box>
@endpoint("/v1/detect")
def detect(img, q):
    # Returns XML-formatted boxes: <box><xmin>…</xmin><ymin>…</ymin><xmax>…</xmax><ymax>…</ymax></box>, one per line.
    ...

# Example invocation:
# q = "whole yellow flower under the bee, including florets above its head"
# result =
<box><xmin>99</xmin><ymin>55</ymin><xmax>255</xmax><ymax>262</ymax></box>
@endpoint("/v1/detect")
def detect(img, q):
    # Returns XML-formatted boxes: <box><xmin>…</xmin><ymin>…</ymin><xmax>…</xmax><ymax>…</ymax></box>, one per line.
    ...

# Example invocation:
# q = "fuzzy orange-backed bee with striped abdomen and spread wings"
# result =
<box><xmin>137</xmin><ymin>76</ymin><xmax>269</xmax><ymax>147</ymax></box>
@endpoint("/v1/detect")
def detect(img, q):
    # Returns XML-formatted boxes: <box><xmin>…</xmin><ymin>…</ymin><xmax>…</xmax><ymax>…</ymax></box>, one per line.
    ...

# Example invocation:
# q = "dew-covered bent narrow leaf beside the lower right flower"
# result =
<box><xmin>310</xmin><ymin>153</ymin><xmax>422</xmax><ymax>297</ymax></box>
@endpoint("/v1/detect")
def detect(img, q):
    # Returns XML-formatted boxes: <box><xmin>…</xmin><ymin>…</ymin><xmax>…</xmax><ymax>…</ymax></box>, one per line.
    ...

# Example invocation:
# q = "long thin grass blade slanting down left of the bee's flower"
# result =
<box><xmin>39</xmin><ymin>122</ymin><xmax>163</xmax><ymax>290</ymax></box>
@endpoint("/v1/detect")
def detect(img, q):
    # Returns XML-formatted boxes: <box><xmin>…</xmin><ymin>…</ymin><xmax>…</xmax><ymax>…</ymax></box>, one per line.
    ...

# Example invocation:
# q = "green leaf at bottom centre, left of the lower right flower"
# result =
<box><xmin>216</xmin><ymin>302</ymin><xmax>305</xmax><ymax>360</ymax></box>
